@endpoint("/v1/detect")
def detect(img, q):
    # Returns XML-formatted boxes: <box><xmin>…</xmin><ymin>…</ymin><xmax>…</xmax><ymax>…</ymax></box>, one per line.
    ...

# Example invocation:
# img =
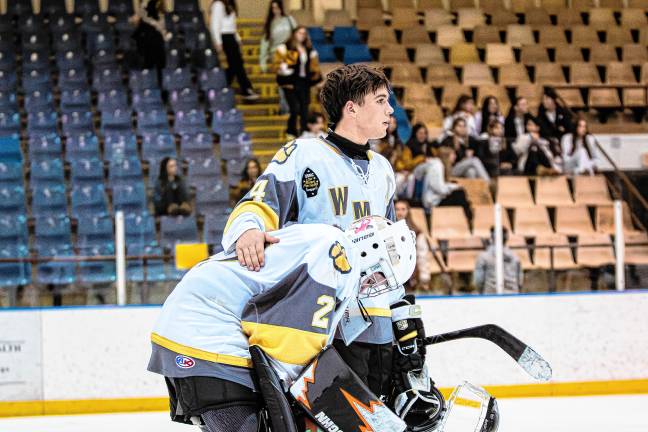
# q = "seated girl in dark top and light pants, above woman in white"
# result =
<box><xmin>441</xmin><ymin>117</ymin><xmax>490</xmax><ymax>181</ymax></box>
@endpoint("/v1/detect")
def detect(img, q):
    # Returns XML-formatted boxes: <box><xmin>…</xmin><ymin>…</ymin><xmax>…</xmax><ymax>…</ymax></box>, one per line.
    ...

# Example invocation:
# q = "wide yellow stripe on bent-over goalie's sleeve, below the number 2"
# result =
<box><xmin>241</xmin><ymin>321</ymin><xmax>328</xmax><ymax>366</ymax></box>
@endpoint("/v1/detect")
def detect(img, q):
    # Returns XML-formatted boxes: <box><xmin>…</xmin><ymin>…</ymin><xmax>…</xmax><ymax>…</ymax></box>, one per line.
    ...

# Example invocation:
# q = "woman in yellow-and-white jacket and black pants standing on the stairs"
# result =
<box><xmin>275</xmin><ymin>26</ymin><xmax>322</xmax><ymax>136</ymax></box>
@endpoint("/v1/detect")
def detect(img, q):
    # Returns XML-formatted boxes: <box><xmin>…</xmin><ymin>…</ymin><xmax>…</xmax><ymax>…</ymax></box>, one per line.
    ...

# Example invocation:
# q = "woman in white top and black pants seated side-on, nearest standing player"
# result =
<box><xmin>422</xmin><ymin>147</ymin><xmax>472</xmax><ymax>220</ymax></box>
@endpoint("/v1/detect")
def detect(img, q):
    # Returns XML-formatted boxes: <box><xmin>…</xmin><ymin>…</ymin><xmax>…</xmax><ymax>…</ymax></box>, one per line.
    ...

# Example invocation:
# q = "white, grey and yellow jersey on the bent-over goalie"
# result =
<box><xmin>149</xmin><ymin>225</ymin><xmax>360</xmax><ymax>387</ymax></box>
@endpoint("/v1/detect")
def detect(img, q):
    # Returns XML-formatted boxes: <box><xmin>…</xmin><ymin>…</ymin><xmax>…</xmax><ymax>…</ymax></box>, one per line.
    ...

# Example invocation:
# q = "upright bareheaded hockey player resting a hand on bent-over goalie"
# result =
<box><xmin>223</xmin><ymin>65</ymin><xmax>420</xmax><ymax>395</ymax></box>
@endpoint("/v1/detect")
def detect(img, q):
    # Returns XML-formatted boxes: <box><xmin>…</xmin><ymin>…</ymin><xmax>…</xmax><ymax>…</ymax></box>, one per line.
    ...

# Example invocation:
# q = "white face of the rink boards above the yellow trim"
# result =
<box><xmin>0</xmin><ymin>291</ymin><xmax>648</xmax><ymax>401</ymax></box>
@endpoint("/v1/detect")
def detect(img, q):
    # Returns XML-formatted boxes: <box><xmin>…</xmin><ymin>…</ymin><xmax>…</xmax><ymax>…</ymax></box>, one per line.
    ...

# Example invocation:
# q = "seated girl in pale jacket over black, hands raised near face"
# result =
<box><xmin>513</xmin><ymin>116</ymin><xmax>562</xmax><ymax>175</ymax></box>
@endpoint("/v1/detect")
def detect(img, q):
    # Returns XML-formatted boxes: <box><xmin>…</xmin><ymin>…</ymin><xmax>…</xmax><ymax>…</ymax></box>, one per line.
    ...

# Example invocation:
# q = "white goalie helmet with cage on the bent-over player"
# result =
<box><xmin>346</xmin><ymin>216</ymin><xmax>416</xmax><ymax>297</ymax></box>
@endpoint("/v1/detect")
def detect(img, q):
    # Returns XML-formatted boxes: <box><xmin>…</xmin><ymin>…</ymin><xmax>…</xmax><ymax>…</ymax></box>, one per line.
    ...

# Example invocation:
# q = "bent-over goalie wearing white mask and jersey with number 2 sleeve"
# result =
<box><xmin>148</xmin><ymin>217</ymin><xmax>416</xmax><ymax>432</ymax></box>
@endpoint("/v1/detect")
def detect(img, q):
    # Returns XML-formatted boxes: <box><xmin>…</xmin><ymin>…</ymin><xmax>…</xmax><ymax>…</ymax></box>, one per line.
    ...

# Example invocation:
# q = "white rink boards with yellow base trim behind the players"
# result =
<box><xmin>0</xmin><ymin>291</ymin><xmax>648</xmax><ymax>416</ymax></box>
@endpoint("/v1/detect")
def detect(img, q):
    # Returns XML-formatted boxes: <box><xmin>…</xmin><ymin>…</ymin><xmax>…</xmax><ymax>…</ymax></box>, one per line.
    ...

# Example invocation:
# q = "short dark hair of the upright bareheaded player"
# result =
<box><xmin>320</xmin><ymin>64</ymin><xmax>391</xmax><ymax>126</ymax></box>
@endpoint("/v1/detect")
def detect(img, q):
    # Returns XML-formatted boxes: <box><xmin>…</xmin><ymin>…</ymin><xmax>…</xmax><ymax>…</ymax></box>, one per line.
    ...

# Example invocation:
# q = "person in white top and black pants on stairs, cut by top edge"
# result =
<box><xmin>210</xmin><ymin>0</ymin><xmax>259</xmax><ymax>100</ymax></box>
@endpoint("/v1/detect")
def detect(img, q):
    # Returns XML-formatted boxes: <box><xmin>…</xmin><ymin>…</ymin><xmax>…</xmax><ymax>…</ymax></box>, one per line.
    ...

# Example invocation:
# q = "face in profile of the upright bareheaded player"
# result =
<box><xmin>354</xmin><ymin>88</ymin><xmax>394</xmax><ymax>140</ymax></box>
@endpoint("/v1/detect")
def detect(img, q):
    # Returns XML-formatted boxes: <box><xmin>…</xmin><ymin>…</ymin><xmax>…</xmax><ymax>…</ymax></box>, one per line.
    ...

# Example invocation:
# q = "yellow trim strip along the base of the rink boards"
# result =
<box><xmin>0</xmin><ymin>379</ymin><xmax>648</xmax><ymax>417</ymax></box>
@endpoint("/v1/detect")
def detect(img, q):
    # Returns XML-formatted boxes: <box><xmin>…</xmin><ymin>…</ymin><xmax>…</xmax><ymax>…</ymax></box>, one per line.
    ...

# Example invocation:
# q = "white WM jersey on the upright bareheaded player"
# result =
<box><xmin>223</xmin><ymin>138</ymin><xmax>404</xmax><ymax>344</ymax></box>
